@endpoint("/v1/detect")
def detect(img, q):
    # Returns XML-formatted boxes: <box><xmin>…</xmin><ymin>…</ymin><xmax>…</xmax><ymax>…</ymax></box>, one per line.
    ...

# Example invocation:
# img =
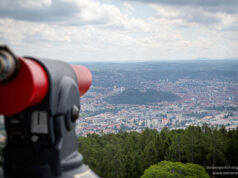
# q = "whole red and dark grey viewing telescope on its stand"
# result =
<box><xmin>0</xmin><ymin>46</ymin><xmax>97</xmax><ymax>178</ymax></box>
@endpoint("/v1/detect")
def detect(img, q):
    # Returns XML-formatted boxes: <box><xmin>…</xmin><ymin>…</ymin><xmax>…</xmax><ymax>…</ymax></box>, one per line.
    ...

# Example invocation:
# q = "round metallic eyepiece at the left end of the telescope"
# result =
<box><xmin>0</xmin><ymin>46</ymin><xmax>18</xmax><ymax>82</ymax></box>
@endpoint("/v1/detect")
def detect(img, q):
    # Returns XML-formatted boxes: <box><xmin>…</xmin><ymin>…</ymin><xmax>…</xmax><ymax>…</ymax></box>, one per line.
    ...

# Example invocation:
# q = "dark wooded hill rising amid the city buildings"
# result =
<box><xmin>105</xmin><ymin>89</ymin><xmax>180</xmax><ymax>104</ymax></box>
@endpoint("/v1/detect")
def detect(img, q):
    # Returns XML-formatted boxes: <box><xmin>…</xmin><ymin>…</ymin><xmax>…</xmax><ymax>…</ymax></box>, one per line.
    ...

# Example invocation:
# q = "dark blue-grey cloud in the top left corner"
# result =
<box><xmin>0</xmin><ymin>0</ymin><xmax>80</xmax><ymax>22</ymax></box>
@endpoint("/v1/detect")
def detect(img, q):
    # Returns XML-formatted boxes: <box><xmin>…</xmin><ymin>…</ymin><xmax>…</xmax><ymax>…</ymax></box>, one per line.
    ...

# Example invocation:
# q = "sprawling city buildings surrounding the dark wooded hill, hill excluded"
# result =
<box><xmin>76</xmin><ymin>60</ymin><xmax>238</xmax><ymax>136</ymax></box>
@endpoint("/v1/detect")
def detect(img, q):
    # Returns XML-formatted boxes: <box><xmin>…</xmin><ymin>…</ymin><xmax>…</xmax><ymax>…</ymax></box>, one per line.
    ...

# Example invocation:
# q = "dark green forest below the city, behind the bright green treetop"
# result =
<box><xmin>79</xmin><ymin>125</ymin><xmax>238</xmax><ymax>178</ymax></box>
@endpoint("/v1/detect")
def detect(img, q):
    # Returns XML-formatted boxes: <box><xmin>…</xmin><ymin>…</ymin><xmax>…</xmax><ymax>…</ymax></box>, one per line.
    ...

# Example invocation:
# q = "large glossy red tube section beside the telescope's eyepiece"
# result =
<box><xmin>0</xmin><ymin>57</ymin><xmax>49</xmax><ymax>116</ymax></box>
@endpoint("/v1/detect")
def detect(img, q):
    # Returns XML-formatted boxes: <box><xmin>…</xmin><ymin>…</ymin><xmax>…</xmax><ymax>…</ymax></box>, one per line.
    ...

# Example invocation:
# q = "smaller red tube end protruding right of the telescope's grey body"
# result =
<box><xmin>72</xmin><ymin>65</ymin><xmax>93</xmax><ymax>97</ymax></box>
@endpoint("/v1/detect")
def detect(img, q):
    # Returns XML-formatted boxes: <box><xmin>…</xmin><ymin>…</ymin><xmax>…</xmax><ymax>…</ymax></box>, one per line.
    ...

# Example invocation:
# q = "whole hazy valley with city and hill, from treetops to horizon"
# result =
<box><xmin>76</xmin><ymin>60</ymin><xmax>238</xmax><ymax>136</ymax></box>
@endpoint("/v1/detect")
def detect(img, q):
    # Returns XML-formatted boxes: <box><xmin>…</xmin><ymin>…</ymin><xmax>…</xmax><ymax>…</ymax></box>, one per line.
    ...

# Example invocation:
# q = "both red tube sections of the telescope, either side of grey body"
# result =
<box><xmin>0</xmin><ymin>57</ymin><xmax>92</xmax><ymax>116</ymax></box>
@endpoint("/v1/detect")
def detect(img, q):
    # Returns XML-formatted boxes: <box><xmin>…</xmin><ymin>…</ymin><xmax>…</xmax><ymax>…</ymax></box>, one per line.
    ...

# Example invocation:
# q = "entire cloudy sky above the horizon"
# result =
<box><xmin>0</xmin><ymin>0</ymin><xmax>238</xmax><ymax>62</ymax></box>
